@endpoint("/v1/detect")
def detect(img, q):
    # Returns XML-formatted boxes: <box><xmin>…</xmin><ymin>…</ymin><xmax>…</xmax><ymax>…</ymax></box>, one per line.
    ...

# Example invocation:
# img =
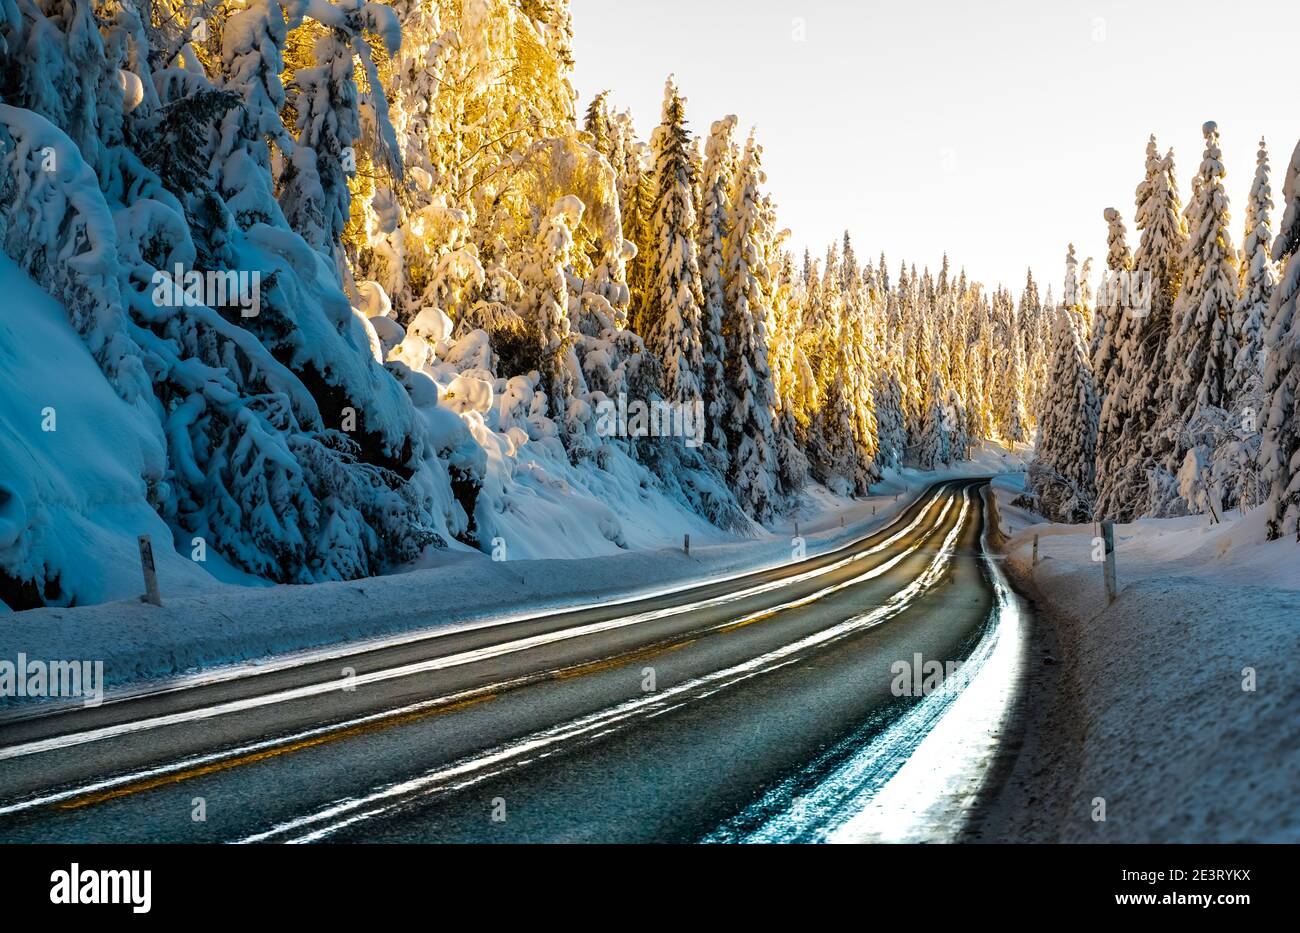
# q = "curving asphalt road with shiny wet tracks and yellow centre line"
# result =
<box><xmin>0</xmin><ymin>479</ymin><xmax>1019</xmax><ymax>842</ymax></box>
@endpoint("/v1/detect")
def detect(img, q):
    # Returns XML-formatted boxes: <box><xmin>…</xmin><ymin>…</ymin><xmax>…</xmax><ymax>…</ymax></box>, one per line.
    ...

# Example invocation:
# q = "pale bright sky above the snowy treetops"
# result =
<box><xmin>572</xmin><ymin>0</ymin><xmax>1300</xmax><ymax>295</ymax></box>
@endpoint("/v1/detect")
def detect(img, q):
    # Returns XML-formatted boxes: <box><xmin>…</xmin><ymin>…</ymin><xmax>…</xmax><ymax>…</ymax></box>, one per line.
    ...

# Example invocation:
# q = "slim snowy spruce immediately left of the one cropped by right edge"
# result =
<box><xmin>1227</xmin><ymin>139</ymin><xmax>1278</xmax><ymax>415</ymax></box>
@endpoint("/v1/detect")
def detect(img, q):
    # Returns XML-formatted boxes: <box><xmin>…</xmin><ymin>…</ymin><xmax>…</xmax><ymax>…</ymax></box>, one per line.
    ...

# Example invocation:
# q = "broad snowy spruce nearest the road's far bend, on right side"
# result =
<box><xmin>1028</xmin><ymin>308</ymin><xmax>1097</xmax><ymax>522</ymax></box>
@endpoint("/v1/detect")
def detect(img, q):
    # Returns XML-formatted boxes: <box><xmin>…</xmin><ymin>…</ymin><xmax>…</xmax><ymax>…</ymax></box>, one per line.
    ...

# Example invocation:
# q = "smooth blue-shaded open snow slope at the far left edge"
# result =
<box><xmin>0</xmin><ymin>255</ymin><xmax>238</xmax><ymax>604</ymax></box>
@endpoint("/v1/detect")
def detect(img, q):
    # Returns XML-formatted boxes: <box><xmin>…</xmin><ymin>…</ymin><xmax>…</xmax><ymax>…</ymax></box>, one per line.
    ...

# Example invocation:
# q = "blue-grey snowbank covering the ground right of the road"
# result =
<box><xmin>984</xmin><ymin>479</ymin><xmax>1300</xmax><ymax>842</ymax></box>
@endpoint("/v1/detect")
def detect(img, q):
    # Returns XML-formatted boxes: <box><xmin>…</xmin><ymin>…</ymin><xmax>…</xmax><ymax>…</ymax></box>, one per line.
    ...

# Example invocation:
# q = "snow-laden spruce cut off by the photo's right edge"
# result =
<box><xmin>1260</xmin><ymin>134</ymin><xmax>1300</xmax><ymax>539</ymax></box>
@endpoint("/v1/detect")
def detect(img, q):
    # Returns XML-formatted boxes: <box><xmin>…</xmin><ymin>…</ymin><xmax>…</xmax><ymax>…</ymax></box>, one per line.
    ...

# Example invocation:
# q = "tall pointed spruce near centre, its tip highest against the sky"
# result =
<box><xmin>637</xmin><ymin>77</ymin><xmax>705</xmax><ymax>405</ymax></box>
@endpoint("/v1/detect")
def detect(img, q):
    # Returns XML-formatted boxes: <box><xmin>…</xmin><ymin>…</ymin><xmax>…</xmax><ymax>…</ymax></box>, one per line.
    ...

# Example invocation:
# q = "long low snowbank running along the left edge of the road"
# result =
<box><xmin>0</xmin><ymin>444</ymin><xmax>1022</xmax><ymax>707</ymax></box>
